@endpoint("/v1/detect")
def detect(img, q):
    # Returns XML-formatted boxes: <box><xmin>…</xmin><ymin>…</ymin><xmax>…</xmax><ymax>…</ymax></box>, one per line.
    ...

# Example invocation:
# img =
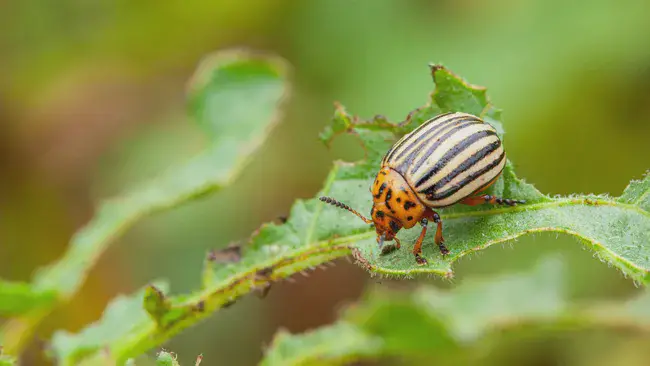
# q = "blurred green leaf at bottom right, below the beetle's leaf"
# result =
<box><xmin>262</xmin><ymin>258</ymin><xmax>650</xmax><ymax>366</ymax></box>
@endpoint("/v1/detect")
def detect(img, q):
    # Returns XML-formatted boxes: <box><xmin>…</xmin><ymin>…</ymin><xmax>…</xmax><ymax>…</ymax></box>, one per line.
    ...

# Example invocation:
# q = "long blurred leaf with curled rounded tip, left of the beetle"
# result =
<box><xmin>0</xmin><ymin>51</ymin><xmax>289</xmax><ymax>353</ymax></box>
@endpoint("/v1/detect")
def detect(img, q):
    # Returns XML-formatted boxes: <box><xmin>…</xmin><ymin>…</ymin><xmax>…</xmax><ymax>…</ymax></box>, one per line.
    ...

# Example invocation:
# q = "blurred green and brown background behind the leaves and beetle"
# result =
<box><xmin>0</xmin><ymin>0</ymin><xmax>650</xmax><ymax>366</ymax></box>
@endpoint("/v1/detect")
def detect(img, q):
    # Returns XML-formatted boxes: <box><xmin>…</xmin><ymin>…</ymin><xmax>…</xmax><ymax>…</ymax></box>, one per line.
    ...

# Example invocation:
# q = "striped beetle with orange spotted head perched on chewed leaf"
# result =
<box><xmin>320</xmin><ymin>112</ymin><xmax>525</xmax><ymax>265</ymax></box>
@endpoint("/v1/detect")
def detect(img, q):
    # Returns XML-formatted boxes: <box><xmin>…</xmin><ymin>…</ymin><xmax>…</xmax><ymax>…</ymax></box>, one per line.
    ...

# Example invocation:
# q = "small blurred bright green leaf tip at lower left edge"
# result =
<box><xmin>0</xmin><ymin>280</ymin><xmax>56</xmax><ymax>316</ymax></box>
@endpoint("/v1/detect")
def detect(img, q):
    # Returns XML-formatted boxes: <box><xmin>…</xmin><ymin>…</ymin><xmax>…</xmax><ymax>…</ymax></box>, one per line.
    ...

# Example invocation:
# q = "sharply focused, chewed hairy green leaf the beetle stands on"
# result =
<box><xmin>45</xmin><ymin>62</ymin><xmax>650</xmax><ymax>362</ymax></box>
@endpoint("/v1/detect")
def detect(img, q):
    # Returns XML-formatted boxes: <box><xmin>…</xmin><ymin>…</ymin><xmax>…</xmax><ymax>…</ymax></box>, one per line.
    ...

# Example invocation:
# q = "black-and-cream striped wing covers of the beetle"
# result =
<box><xmin>382</xmin><ymin>113</ymin><xmax>506</xmax><ymax>207</ymax></box>
